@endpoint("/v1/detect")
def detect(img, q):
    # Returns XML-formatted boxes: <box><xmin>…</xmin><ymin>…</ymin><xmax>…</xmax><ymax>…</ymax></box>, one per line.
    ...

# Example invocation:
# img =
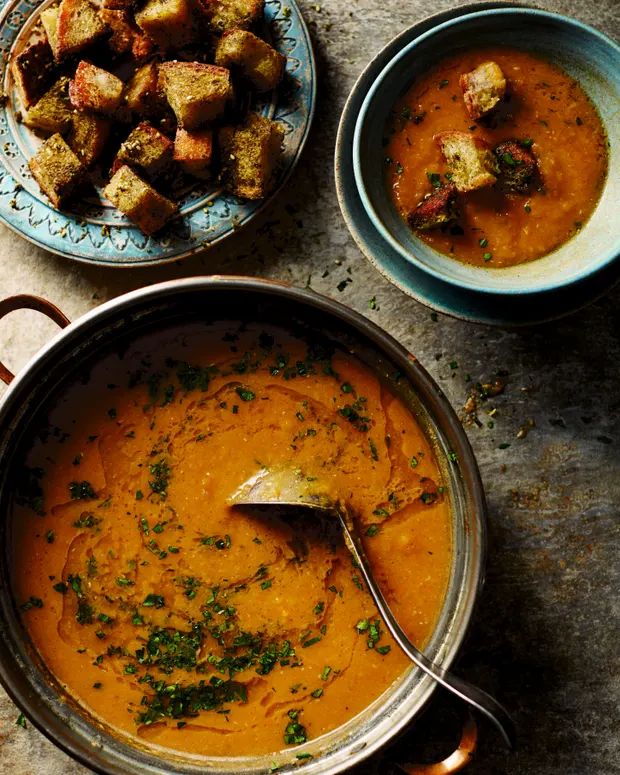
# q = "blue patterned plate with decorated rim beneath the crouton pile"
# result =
<box><xmin>0</xmin><ymin>0</ymin><xmax>316</xmax><ymax>267</ymax></box>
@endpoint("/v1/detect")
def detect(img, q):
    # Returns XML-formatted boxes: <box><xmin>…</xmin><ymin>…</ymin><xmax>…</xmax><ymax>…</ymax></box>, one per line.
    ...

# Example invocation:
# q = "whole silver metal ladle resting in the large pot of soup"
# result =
<box><xmin>228</xmin><ymin>468</ymin><xmax>516</xmax><ymax>748</ymax></box>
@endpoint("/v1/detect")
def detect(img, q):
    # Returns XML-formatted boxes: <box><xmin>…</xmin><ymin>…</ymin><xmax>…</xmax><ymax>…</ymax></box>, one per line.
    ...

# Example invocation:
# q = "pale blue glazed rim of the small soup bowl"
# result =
<box><xmin>353</xmin><ymin>6</ymin><xmax>620</xmax><ymax>296</ymax></box>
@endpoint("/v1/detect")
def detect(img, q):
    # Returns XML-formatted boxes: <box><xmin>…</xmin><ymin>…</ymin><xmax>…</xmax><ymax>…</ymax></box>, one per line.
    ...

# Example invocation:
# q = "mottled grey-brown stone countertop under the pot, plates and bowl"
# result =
<box><xmin>0</xmin><ymin>0</ymin><xmax>620</xmax><ymax>775</ymax></box>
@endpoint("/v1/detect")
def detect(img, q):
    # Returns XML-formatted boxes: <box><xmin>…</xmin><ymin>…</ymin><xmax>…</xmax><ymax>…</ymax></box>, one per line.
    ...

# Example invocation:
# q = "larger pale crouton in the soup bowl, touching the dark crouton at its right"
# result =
<box><xmin>434</xmin><ymin>131</ymin><xmax>497</xmax><ymax>192</ymax></box>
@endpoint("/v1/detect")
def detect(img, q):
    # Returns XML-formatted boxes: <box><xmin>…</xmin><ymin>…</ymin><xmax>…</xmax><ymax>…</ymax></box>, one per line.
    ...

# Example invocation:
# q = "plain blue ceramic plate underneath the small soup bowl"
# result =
<box><xmin>335</xmin><ymin>2</ymin><xmax>618</xmax><ymax>327</ymax></box>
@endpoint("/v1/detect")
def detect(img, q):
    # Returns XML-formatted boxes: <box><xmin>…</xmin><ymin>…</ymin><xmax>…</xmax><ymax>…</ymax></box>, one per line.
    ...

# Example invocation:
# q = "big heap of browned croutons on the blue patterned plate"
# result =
<box><xmin>11</xmin><ymin>0</ymin><xmax>286</xmax><ymax>234</ymax></box>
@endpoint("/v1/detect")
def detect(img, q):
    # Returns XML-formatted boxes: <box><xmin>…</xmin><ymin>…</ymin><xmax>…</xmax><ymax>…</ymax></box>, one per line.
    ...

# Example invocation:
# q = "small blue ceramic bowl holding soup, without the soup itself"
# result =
<box><xmin>353</xmin><ymin>7</ymin><xmax>620</xmax><ymax>295</ymax></box>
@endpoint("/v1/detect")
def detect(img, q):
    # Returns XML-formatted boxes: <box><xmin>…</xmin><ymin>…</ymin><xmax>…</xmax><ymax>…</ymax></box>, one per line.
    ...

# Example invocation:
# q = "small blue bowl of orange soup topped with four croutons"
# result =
<box><xmin>353</xmin><ymin>8</ymin><xmax>620</xmax><ymax>294</ymax></box>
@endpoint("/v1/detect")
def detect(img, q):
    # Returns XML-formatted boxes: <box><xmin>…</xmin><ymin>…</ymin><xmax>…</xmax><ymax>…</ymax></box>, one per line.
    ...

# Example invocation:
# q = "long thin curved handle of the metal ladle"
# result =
<box><xmin>338</xmin><ymin>509</ymin><xmax>516</xmax><ymax>748</ymax></box>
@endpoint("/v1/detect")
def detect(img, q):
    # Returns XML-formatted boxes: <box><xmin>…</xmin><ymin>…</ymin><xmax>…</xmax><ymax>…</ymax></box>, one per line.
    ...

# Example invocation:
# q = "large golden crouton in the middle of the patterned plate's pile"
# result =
<box><xmin>159</xmin><ymin>61</ymin><xmax>233</xmax><ymax>129</ymax></box>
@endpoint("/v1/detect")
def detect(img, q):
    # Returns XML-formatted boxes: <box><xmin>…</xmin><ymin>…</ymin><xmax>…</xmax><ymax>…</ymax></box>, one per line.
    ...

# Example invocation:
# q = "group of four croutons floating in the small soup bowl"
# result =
<box><xmin>408</xmin><ymin>62</ymin><xmax>538</xmax><ymax>230</ymax></box>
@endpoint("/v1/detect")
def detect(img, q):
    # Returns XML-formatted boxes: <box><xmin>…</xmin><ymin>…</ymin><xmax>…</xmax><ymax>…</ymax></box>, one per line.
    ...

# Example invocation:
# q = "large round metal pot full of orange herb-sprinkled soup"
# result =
<box><xmin>0</xmin><ymin>278</ymin><xmax>485</xmax><ymax>775</ymax></box>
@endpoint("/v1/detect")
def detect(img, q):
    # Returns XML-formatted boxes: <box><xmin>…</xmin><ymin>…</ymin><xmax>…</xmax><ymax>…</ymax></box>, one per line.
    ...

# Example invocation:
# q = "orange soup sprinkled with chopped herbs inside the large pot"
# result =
<box><xmin>12</xmin><ymin>323</ymin><xmax>451</xmax><ymax>755</ymax></box>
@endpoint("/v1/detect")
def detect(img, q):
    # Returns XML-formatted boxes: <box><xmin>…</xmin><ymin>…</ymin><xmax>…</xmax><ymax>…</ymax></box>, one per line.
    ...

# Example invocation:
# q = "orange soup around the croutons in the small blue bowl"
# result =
<box><xmin>385</xmin><ymin>47</ymin><xmax>608</xmax><ymax>268</ymax></box>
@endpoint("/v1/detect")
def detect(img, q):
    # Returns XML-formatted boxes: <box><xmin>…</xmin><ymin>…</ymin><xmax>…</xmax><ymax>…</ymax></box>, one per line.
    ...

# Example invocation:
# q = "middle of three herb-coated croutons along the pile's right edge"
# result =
<box><xmin>215</xmin><ymin>30</ymin><xmax>286</xmax><ymax>92</ymax></box>
